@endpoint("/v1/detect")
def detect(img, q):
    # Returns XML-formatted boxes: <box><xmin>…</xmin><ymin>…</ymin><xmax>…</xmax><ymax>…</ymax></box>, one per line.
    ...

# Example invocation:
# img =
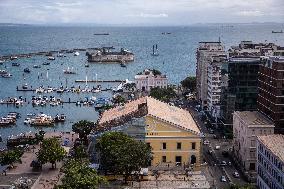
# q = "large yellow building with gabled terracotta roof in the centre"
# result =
<box><xmin>98</xmin><ymin>97</ymin><xmax>201</xmax><ymax>169</ymax></box>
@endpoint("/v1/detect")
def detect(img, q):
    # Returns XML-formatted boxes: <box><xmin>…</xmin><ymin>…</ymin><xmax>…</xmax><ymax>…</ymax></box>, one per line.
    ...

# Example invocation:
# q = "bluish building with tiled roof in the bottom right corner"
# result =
<box><xmin>257</xmin><ymin>135</ymin><xmax>284</xmax><ymax>189</ymax></box>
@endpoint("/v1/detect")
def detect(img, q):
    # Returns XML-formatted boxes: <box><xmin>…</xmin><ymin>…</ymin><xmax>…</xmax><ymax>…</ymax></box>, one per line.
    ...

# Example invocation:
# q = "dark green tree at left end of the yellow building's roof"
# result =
<box><xmin>72</xmin><ymin>120</ymin><xmax>95</xmax><ymax>144</ymax></box>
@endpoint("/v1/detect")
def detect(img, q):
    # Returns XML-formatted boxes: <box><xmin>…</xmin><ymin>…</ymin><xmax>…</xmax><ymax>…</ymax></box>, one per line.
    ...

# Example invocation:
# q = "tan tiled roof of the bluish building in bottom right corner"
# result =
<box><xmin>257</xmin><ymin>135</ymin><xmax>284</xmax><ymax>162</ymax></box>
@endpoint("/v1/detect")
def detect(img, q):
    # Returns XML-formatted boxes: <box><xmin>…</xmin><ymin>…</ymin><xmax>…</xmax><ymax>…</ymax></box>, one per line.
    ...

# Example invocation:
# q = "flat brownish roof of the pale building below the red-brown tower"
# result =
<box><xmin>234</xmin><ymin>111</ymin><xmax>274</xmax><ymax>127</ymax></box>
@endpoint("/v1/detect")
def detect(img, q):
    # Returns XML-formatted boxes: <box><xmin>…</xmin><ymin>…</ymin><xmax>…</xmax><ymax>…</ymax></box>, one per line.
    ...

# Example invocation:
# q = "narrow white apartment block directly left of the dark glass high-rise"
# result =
<box><xmin>207</xmin><ymin>55</ymin><xmax>227</xmax><ymax>118</ymax></box>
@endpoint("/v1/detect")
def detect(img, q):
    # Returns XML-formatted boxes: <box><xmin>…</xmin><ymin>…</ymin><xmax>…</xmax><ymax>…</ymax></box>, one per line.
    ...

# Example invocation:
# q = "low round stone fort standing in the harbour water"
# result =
<box><xmin>86</xmin><ymin>47</ymin><xmax>134</xmax><ymax>62</ymax></box>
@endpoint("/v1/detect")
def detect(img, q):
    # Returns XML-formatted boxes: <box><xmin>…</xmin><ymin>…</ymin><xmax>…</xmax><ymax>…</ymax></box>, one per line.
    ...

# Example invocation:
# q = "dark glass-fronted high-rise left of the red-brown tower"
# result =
<box><xmin>221</xmin><ymin>58</ymin><xmax>261</xmax><ymax>123</ymax></box>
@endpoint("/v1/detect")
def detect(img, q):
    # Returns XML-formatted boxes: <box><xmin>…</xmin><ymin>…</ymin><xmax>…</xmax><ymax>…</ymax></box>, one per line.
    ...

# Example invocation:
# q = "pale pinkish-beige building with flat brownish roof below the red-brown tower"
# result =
<box><xmin>233</xmin><ymin>111</ymin><xmax>274</xmax><ymax>179</ymax></box>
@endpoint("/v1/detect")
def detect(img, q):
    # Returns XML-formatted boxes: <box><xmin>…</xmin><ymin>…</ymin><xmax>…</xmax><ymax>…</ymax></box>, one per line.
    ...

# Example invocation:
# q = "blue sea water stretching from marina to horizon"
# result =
<box><xmin>0</xmin><ymin>24</ymin><xmax>284</xmax><ymax>145</ymax></box>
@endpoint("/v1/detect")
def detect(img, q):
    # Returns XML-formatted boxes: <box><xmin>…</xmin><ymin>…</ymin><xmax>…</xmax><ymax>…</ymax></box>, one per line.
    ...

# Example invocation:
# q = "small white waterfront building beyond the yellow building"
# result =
<box><xmin>134</xmin><ymin>70</ymin><xmax>168</xmax><ymax>92</ymax></box>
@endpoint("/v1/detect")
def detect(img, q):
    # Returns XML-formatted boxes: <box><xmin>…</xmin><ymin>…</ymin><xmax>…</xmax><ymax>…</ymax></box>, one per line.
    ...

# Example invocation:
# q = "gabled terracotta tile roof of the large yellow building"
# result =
<box><xmin>98</xmin><ymin>97</ymin><xmax>200</xmax><ymax>134</ymax></box>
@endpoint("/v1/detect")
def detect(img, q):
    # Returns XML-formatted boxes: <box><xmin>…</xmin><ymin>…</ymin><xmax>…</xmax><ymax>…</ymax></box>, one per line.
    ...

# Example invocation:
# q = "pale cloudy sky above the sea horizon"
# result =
<box><xmin>0</xmin><ymin>0</ymin><xmax>284</xmax><ymax>25</ymax></box>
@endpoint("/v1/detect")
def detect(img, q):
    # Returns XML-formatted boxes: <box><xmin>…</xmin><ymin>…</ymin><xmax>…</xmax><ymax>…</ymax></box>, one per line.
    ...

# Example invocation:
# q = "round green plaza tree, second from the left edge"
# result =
<box><xmin>37</xmin><ymin>138</ymin><xmax>66</xmax><ymax>168</ymax></box>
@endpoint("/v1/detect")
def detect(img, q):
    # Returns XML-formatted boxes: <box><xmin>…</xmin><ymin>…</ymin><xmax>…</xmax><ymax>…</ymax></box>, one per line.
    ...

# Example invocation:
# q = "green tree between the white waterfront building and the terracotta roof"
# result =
<box><xmin>150</xmin><ymin>87</ymin><xmax>177</xmax><ymax>102</ymax></box>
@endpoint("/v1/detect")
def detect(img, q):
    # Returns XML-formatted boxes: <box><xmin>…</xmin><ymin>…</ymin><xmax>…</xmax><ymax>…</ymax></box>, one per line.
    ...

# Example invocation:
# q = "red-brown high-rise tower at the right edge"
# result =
<box><xmin>257</xmin><ymin>57</ymin><xmax>284</xmax><ymax>134</ymax></box>
